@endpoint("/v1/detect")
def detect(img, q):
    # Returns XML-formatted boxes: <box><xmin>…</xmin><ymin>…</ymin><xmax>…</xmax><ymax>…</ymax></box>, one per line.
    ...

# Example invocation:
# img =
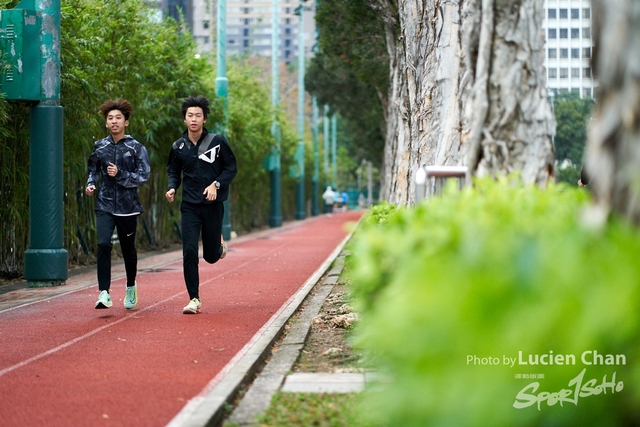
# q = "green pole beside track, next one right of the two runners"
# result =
<box><xmin>269</xmin><ymin>0</ymin><xmax>282</xmax><ymax>227</ymax></box>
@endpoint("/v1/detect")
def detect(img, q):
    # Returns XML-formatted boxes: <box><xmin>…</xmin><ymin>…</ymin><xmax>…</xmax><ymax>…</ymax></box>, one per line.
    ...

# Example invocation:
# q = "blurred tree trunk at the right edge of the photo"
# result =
<box><xmin>585</xmin><ymin>0</ymin><xmax>640</xmax><ymax>224</ymax></box>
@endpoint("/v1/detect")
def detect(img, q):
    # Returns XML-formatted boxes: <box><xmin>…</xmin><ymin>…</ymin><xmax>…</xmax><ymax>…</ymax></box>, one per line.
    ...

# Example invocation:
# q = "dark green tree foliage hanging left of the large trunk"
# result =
<box><xmin>305</xmin><ymin>0</ymin><xmax>389</xmax><ymax>171</ymax></box>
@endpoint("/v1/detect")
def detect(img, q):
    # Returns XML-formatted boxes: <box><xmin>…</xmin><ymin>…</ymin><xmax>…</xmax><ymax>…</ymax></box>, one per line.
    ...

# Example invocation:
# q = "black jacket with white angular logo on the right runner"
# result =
<box><xmin>167</xmin><ymin>128</ymin><xmax>238</xmax><ymax>203</ymax></box>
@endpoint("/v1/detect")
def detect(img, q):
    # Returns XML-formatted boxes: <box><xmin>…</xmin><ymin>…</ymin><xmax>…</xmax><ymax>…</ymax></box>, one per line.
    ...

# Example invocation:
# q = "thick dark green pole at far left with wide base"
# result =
<box><xmin>24</xmin><ymin>0</ymin><xmax>68</xmax><ymax>287</ymax></box>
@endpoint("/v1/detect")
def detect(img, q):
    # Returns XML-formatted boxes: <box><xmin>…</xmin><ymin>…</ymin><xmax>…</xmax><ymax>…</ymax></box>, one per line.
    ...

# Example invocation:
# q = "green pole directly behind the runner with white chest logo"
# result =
<box><xmin>216</xmin><ymin>0</ymin><xmax>231</xmax><ymax>240</ymax></box>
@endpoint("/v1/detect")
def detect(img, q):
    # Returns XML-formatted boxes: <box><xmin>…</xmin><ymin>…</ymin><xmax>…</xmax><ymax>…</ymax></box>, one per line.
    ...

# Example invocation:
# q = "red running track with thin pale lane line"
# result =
<box><xmin>0</xmin><ymin>212</ymin><xmax>360</xmax><ymax>427</ymax></box>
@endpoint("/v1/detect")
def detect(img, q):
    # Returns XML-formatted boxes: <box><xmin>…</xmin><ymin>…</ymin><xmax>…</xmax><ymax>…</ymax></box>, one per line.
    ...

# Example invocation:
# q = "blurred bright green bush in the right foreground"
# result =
<box><xmin>351</xmin><ymin>176</ymin><xmax>640</xmax><ymax>427</ymax></box>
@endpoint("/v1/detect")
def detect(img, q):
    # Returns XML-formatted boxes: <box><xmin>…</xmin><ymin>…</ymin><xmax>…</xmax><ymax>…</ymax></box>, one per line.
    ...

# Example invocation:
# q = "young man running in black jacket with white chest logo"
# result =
<box><xmin>165</xmin><ymin>96</ymin><xmax>238</xmax><ymax>314</ymax></box>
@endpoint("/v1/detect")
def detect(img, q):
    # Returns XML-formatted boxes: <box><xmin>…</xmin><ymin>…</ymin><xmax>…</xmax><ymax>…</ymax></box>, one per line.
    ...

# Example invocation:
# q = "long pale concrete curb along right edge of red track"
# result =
<box><xmin>167</xmin><ymin>227</ymin><xmax>353</xmax><ymax>427</ymax></box>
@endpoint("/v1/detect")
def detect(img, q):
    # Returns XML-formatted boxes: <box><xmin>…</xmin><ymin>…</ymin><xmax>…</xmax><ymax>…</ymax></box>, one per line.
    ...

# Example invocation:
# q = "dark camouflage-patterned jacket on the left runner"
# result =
<box><xmin>86</xmin><ymin>135</ymin><xmax>151</xmax><ymax>215</ymax></box>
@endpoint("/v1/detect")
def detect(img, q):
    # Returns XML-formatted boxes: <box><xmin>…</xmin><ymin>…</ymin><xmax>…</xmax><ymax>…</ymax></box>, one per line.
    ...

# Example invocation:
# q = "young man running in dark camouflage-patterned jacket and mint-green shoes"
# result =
<box><xmin>85</xmin><ymin>99</ymin><xmax>151</xmax><ymax>310</ymax></box>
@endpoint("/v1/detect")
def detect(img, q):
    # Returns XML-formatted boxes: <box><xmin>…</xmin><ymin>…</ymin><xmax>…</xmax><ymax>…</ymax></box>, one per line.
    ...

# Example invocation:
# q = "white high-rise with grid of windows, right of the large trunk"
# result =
<box><xmin>543</xmin><ymin>0</ymin><xmax>597</xmax><ymax>98</ymax></box>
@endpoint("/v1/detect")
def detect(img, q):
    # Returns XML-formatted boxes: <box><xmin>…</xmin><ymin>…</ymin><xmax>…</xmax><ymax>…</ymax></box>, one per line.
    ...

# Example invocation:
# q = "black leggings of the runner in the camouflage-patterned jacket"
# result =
<box><xmin>96</xmin><ymin>211</ymin><xmax>138</xmax><ymax>291</ymax></box>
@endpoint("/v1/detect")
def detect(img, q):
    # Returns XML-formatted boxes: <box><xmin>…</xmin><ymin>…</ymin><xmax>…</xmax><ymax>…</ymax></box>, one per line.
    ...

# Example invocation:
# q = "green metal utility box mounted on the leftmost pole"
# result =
<box><xmin>0</xmin><ymin>9</ymin><xmax>42</xmax><ymax>101</ymax></box>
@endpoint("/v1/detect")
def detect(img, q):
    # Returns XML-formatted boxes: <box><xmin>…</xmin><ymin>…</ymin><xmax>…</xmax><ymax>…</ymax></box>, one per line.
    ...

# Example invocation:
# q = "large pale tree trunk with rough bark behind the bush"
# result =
<box><xmin>370</xmin><ymin>0</ymin><xmax>555</xmax><ymax>205</ymax></box>
